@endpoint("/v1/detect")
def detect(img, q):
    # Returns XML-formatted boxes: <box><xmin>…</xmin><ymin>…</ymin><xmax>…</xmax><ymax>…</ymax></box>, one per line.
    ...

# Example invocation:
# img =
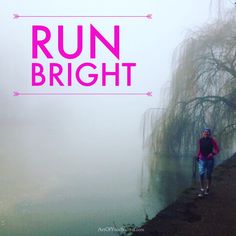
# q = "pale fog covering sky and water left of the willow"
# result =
<box><xmin>0</xmin><ymin>0</ymin><xmax>232</xmax><ymax>236</ymax></box>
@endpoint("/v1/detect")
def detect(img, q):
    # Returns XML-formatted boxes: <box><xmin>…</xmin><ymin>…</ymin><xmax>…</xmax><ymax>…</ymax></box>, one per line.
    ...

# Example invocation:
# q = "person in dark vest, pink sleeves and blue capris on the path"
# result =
<box><xmin>197</xmin><ymin>128</ymin><xmax>220</xmax><ymax>197</ymax></box>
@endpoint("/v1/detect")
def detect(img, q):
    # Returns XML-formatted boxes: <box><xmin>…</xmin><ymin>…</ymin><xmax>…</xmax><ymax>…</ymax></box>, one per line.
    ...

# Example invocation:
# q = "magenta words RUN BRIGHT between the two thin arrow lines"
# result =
<box><xmin>32</xmin><ymin>24</ymin><xmax>136</xmax><ymax>86</ymax></box>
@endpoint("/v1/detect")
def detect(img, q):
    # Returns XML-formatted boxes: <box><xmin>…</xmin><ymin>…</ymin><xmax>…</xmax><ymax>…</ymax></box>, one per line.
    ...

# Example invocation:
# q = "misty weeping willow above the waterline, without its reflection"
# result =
<box><xmin>148</xmin><ymin>12</ymin><xmax>236</xmax><ymax>162</ymax></box>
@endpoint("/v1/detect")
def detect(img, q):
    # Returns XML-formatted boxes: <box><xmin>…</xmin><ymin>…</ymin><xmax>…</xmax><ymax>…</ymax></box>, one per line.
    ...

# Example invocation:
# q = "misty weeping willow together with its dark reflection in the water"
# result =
<box><xmin>138</xmin><ymin>9</ymin><xmax>236</xmax><ymax>204</ymax></box>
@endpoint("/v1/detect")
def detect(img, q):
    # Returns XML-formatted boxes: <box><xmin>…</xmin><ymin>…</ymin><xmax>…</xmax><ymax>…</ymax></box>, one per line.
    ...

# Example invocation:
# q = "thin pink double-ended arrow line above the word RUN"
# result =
<box><xmin>13</xmin><ymin>13</ymin><xmax>152</xmax><ymax>20</ymax></box>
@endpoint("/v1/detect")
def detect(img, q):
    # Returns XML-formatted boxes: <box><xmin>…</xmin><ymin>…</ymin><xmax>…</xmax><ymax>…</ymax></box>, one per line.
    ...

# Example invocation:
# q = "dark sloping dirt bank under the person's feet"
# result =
<box><xmin>133</xmin><ymin>153</ymin><xmax>236</xmax><ymax>236</ymax></box>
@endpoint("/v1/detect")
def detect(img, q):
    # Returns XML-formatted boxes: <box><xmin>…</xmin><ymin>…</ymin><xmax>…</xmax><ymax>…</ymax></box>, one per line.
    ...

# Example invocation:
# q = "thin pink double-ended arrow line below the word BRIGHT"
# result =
<box><xmin>13</xmin><ymin>91</ymin><xmax>152</xmax><ymax>97</ymax></box>
